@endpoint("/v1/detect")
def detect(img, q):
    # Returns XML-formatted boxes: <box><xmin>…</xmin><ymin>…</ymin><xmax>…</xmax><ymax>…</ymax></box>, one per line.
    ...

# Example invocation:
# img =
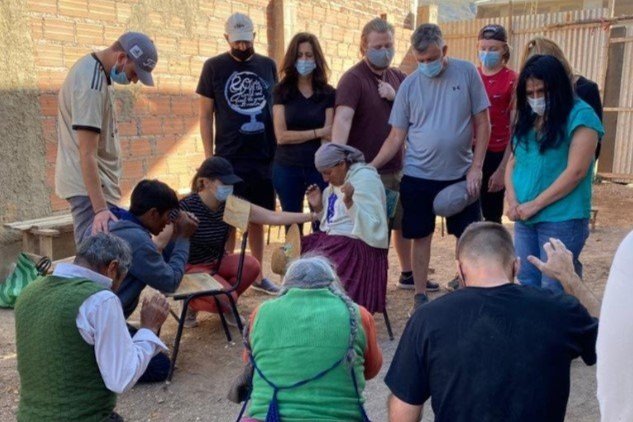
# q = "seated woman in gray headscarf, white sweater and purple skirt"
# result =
<box><xmin>301</xmin><ymin>143</ymin><xmax>388</xmax><ymax>313</ymax></box>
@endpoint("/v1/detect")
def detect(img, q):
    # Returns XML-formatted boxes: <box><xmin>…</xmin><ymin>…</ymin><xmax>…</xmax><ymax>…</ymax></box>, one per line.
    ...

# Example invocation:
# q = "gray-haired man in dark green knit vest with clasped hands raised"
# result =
<box><xmin>15</xmin><ymin>233</ymin><xmax>169</xmax><ymax>422</ymax></box>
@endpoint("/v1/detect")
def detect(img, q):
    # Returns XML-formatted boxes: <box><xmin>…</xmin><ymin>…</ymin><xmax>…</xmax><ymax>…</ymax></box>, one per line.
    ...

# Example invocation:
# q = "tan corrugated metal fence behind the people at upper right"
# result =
<box><xmin>434</xmin><ymin>9</ymin><xmax>633</xmax><ymax>177</ymax></box>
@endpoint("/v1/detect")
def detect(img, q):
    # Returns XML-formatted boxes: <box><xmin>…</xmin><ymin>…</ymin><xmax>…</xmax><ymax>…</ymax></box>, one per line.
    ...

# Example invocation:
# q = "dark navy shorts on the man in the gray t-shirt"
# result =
<box><xmin>400</xmin><ymin>176</ymin><xmax>481</xmax><ymax>239</ymax></box>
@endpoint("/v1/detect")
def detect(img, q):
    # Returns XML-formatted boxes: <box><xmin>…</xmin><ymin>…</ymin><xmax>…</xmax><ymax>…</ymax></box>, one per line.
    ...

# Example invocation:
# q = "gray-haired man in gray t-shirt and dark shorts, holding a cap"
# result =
<box><xmin>371</xmin><ymin>24</ymin><xmax>490</xmax><ymax>312</ymax></box>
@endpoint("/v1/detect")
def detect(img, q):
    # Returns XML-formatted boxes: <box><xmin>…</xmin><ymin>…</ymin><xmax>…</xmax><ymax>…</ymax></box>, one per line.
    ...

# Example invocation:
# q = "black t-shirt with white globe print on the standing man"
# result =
<box><xmin>196</xmin><ymin>53</ymin><xmax>277</xmax><ymax>175</ymax></box>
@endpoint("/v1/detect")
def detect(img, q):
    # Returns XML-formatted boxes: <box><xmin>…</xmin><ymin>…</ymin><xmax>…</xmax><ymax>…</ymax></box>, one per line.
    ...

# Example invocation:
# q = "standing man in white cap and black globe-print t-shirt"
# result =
<box><xmin>196</xmin><ymin>13</ymin><xmax>279</xmax><ymax>294</ymax></box>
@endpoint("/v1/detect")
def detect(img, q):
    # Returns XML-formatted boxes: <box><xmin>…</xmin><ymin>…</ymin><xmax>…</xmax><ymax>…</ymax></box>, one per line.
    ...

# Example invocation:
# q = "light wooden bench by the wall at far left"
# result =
<box><xmin>4</xmin><ymin>214</ymin><xmax>73</xmax><ymax>258</ymax></box>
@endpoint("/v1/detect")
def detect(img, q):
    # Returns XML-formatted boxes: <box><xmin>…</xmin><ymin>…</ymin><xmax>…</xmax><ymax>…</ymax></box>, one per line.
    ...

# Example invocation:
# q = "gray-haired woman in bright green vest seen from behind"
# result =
<box><xmin>245</xmin><ymin>256</ymin><xmax>382</xmax><ymax>422</ymax></box>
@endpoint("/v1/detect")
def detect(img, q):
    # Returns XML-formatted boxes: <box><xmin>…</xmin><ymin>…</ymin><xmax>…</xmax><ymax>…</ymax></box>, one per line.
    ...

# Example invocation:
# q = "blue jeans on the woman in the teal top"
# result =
<box><xmin>514</xmin><ymin>218</ymin><xmax>589</xmax><ymax>292</ymax></box>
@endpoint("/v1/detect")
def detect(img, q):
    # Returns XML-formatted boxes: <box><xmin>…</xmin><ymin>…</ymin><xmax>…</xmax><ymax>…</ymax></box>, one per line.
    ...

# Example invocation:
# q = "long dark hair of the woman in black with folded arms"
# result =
<box><xmin>274</xmin><ymin>32</ymin><xmax>332</xmax><ymax>100</ymax></box>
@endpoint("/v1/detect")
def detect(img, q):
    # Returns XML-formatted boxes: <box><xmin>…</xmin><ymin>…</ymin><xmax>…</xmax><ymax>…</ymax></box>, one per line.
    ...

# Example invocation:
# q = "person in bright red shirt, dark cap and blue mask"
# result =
<box><xmin>477</xmin><ymin>25</ymin><xmax>517</xmax><ymax>223</ymax></box>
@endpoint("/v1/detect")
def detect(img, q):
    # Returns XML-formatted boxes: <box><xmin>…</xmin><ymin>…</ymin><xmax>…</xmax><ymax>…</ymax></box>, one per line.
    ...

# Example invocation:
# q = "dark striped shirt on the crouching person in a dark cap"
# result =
<box><xmin>180</xmin><ymin>193</ymin><xmax>229</xmax><ymax>264</ymax></box>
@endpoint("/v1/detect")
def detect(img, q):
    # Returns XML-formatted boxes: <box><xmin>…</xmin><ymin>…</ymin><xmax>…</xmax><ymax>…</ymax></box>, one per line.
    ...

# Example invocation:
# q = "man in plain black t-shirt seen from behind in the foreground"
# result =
<box><xmin>385</xmin><ymin>223</ymin><xmax>598</xmax><ymax>422</ymax></box>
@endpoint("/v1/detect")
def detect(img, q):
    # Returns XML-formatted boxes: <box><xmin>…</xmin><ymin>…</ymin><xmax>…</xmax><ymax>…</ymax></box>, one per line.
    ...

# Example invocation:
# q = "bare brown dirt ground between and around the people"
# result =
<box><xmin>0</xmin><ymin>184</ymin><xmax>633</xmax><ymax>422</ymax></box>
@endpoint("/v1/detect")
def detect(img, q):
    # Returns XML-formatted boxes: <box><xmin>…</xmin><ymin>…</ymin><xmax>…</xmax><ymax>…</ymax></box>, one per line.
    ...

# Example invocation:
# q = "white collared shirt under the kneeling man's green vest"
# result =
<box><xmin>53</xmin><ymin>263</ymin><xmax>167</xmax><ymax>394</ymax></box>
